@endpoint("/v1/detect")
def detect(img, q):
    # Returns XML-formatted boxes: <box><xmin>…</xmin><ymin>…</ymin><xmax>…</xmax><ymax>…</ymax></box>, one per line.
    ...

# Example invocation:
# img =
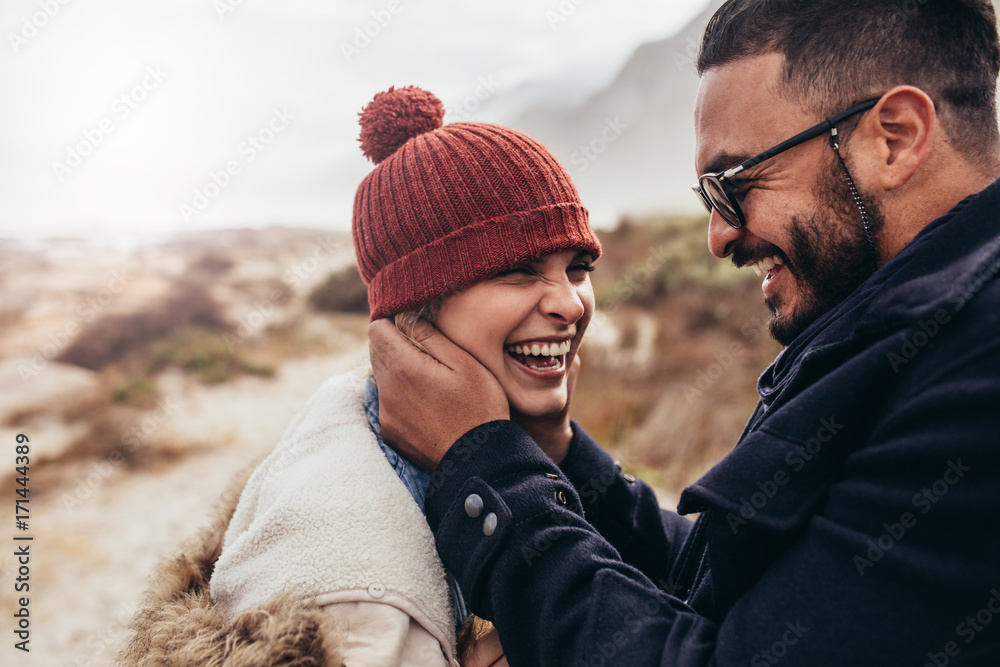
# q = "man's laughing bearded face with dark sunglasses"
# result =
<box><xmin>695</xmin><ymin>55</ymin><xmax>881</xmax><ymax>345</ymax></box>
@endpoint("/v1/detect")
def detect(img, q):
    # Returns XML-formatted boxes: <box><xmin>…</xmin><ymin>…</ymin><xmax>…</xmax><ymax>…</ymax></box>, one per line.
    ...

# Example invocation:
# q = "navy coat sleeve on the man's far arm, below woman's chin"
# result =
<box><xmin>559</xmin><ymin>422</ymin><xmax>692</xmax><ymax>592</ymax></box>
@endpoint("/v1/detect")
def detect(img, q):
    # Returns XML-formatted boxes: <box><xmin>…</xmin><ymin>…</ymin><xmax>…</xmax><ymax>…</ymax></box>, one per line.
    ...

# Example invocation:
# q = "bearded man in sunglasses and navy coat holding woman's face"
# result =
<box><xmin>370</xmin><ymin>0</ymin><xmax>1000</xmax><ymax>666</ymax></box>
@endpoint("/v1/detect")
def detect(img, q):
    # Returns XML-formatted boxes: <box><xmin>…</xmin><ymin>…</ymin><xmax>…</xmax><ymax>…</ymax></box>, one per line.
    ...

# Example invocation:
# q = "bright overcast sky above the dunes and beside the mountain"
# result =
<box><xmin>0</xmin><ymin>0</ymin><xmax>707</xmax><ymax>244</ymax></box>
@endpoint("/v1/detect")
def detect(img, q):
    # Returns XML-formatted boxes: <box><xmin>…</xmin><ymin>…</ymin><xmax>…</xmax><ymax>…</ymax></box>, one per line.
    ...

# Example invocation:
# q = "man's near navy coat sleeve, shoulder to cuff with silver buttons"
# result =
<box><xmin>418</xmin><ymin>316</ymin><xmax>1000</xmax><ymax>667</ymax></box>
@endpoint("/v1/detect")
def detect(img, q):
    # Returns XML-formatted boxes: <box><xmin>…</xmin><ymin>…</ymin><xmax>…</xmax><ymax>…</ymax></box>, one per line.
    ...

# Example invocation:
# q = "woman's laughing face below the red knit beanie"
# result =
<box><xmin>434</xmin><ymin>250</ymin><xmax>594</xmax><ymax>417</ymax></box>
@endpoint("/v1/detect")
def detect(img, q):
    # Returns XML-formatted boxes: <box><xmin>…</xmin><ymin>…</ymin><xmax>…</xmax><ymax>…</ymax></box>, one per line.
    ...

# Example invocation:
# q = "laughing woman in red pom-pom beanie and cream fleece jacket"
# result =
<box><xmin>117</xmin><ymin>87</ymin><xmax>601</xmax><ymax>667</ymax></box>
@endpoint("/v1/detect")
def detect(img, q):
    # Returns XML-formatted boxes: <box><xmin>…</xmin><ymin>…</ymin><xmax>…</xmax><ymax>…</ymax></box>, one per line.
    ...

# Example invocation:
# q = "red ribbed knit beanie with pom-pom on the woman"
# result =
<box><xmin>352</xmin><ymin>87</ymin><xmax>601</xmax><ymax>321</ymax></box>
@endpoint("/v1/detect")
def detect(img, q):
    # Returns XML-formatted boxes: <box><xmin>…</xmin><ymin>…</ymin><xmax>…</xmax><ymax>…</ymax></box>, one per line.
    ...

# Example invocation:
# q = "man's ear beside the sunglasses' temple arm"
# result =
<box><xmin>855</xmin><ymin>86</ymin><xmax>937</xmax><ymax>190</ymax></box>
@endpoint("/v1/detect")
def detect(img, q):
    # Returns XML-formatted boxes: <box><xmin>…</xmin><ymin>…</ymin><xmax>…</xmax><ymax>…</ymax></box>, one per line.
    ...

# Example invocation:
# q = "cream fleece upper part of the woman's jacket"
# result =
<box><xmin>211</xmin><ymin>370</ymin><xmax>457</xmax><ymax>665</ymax></box>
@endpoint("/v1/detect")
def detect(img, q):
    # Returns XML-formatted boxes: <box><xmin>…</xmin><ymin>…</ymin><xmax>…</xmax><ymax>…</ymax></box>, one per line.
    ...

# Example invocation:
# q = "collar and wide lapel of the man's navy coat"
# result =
<box><xmin>678</xmin><ymin>181</ymin><xmax>1000</xmax><ymax>533</ymax></box>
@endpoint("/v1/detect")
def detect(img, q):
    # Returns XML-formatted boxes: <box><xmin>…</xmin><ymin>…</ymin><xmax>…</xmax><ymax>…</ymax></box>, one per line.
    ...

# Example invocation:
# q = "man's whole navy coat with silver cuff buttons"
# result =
<box><xmin>427</xmin><ymin>182</ymin><xmax>1000</xmax><ymax>667</ymax></box>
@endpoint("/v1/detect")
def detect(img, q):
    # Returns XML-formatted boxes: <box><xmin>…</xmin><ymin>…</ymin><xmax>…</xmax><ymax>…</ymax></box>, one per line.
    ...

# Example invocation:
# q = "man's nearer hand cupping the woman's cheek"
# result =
<box><xmin>368</xmin><ymin>319</ymin><xmax>510</xmax><ymax>471</ymax></box>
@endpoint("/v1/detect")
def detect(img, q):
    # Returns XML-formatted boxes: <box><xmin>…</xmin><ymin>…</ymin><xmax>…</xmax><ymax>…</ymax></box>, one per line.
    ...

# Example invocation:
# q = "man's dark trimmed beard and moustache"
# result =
<box><xmin>733</xmin><ymin>162</ymin><xmax>884</xmax><ymax>346</ymax></box>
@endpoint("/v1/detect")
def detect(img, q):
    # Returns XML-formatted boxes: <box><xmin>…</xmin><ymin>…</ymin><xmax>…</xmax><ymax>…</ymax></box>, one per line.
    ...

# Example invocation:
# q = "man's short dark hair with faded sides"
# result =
<box><xmin>698</xmin><ymin>0</ymin><xmax>1000</xmax><ymax>165</ymax></box>
